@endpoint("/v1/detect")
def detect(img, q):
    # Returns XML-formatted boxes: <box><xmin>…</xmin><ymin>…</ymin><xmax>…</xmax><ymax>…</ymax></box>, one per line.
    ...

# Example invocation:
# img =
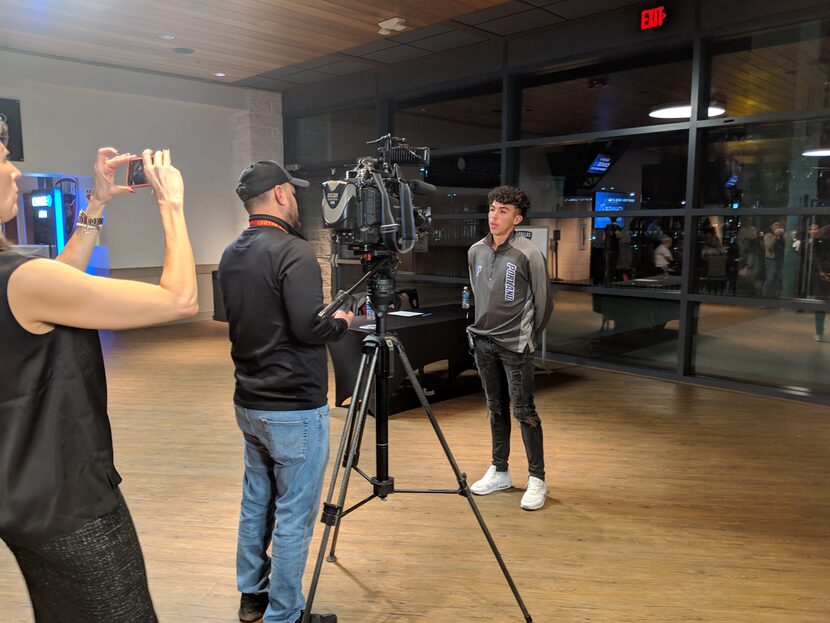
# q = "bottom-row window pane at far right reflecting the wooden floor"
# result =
<box><xmin>694</xmin><ymin>304</ymin><xmax>830</xmax><ymax>394</ymax></box>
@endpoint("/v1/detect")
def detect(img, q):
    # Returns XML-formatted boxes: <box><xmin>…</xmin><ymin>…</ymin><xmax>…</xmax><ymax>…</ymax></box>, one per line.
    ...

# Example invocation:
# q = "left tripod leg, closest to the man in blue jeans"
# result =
<box><xmin>302</xmin><ymin>349</ymin><xmax>378</xmax><ymax>623</ymax></box>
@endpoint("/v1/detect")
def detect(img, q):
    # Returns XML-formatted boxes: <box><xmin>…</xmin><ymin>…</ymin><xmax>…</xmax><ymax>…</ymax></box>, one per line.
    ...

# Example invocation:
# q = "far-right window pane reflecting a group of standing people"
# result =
<box><xmin>694</xmin><ymin>214</ymin><xmax>830</xmax><ymax>300</ymax></box>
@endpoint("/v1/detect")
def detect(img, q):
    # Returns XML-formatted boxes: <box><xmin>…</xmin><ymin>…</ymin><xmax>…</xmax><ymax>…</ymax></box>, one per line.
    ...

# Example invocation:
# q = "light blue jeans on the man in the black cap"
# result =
<box><xmin>235</xmin><ymin>405</ymin><xmax>329</xmax><ymax>623</ymax></box>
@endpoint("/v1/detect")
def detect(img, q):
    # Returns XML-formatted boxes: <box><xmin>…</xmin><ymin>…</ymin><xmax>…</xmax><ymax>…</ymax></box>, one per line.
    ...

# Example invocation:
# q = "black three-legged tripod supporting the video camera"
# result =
<box><xmin>302</xmin><ymin>259</ymin><xmax>533</xmax><ymax>623</ymax></box>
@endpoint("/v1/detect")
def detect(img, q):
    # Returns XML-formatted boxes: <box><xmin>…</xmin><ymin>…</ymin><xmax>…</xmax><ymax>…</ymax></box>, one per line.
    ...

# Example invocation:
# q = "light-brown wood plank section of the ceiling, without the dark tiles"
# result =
<box><xmin>0</xmin><ymin>0</ymin><xmax>506</xmax><ymax>82</ymax></box>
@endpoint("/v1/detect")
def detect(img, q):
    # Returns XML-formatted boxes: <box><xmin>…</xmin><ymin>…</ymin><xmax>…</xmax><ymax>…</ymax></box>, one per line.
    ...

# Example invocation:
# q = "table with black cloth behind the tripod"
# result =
<box><xmin>328</xmin><ymin>305</ymin><xmax>474</xmax><ymax>413</ymax></box>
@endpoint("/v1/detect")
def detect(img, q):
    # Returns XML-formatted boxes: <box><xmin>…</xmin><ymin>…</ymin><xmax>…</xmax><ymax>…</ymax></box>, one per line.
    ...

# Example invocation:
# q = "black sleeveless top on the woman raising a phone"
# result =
<box><xmin>0</xmin><ymin>250</ymin><xmax>121</xmax><ymax>545</ymax></box>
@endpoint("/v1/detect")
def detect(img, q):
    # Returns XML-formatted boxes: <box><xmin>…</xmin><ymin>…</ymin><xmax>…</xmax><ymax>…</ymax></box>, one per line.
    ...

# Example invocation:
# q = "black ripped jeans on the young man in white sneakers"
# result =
<box><xmin>475</xmin><ymin>337</ymin><xmax>545</xmax><ymax>480</ymax></box>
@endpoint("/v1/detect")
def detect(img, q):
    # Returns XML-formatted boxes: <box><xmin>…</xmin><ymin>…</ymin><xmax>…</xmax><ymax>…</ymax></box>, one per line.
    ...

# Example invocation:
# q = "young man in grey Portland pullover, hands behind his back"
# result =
<box><xmin>467</xmin><ymin>186</ymin><xmax>553</xmax><ymax>510</ymax></box>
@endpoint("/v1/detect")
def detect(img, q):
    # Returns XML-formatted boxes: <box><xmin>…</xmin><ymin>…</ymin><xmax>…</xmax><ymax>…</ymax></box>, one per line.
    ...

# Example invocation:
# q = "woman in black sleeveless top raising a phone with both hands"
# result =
<box><xmin>0</xmin><ymin>123</ymin><xmax>198</xmax><ymax>623</ymax></box>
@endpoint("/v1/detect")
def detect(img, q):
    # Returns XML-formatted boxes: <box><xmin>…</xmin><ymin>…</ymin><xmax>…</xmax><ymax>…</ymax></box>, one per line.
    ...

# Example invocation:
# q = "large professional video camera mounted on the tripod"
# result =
<box><xmin>322</xmin><ymin>134</ymin><xmax>436</xmax><ymax>255</ymax></box>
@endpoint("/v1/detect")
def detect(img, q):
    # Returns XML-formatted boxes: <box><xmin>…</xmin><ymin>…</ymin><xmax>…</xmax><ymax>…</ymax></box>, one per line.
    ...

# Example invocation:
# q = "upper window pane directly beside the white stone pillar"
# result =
<box><xmin>291</xmin><ymin>106</ymin><xmax>378</xmax><ymax>165</ymax></box>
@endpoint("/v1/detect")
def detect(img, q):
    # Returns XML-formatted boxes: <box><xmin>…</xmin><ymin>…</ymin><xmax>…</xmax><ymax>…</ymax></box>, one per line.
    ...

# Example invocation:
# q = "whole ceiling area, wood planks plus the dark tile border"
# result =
<box><xmin>0</xmin><ymin>0</ymin><xmax>638</xmax><ymax>91</ymax></box>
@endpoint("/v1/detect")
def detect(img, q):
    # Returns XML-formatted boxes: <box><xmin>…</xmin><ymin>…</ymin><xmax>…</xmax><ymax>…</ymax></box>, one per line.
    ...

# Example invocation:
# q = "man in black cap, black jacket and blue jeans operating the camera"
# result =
<box><xmin>219</xmin><ymin>160</ymin><xmax>354</xmax><ymax>623</ymax></box>
